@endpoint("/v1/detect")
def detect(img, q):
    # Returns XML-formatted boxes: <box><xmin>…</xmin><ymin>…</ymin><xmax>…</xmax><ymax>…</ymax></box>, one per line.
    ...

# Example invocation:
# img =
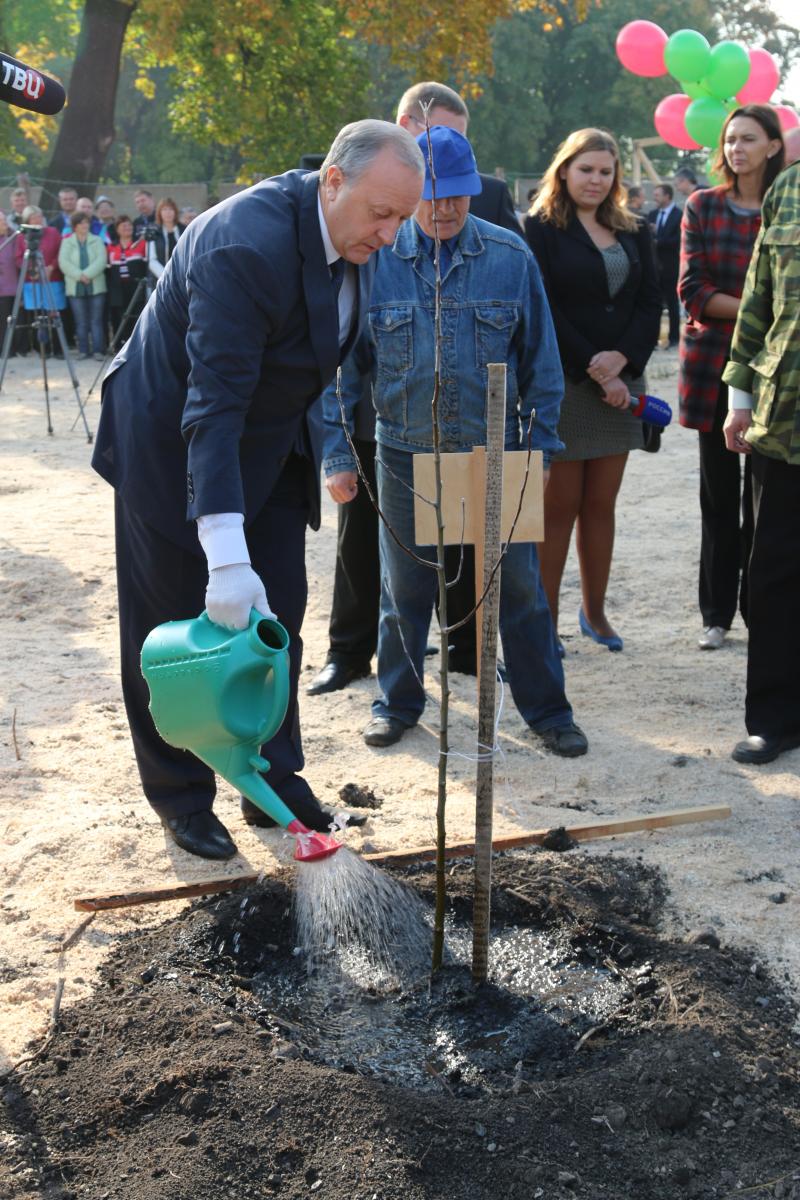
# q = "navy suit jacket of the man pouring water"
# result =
<box><xmin>92</xmin><ymin>170</ymin><xmax>374</xmax><ymax>553</ymax></box>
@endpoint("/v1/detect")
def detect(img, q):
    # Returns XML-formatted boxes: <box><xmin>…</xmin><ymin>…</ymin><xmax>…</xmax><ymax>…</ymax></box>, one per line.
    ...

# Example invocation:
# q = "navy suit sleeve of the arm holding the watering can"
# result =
<box><xmin>181</xmin><ymin>245</ymin><xmax>285</xmax><ymax>520</ymax></box>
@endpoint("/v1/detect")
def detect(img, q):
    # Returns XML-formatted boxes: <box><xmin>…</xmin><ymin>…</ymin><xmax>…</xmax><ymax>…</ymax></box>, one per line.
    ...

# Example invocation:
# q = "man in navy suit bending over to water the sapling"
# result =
<box><xmin>92</xmin><ymin>121</ymin><xmax>423</xmax><ymax>858</ymax></box>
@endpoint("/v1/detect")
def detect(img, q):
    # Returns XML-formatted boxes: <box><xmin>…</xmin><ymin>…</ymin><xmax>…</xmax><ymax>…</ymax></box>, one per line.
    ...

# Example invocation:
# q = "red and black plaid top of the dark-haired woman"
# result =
<box><xmin>678</xmin><ymin>186</ymin><xmax>762</xmax><ymax>433</ymax></box>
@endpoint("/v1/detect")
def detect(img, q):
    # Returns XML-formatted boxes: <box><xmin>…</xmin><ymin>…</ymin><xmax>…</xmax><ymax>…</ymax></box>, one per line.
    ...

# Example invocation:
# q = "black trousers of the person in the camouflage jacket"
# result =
<box><xmin>745</xmin><ymin>450</ymin><xmax>800</xmax><ymax>738</ymax></box>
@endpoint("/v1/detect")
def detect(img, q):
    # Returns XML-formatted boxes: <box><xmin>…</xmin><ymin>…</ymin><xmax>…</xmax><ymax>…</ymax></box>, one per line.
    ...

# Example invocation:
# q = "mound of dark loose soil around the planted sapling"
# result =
<box><xmin>0</xmin><ymin>852</ymin><xmax>800</xmax><ymax>1200</ymax></box>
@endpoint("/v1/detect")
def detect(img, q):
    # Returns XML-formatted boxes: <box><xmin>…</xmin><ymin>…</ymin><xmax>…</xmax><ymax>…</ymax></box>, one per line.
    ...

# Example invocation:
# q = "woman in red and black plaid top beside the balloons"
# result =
<box><xmin>678</xmin><ymin>104</ymin><xmax>783</xmax><ymax>650</ymax></box>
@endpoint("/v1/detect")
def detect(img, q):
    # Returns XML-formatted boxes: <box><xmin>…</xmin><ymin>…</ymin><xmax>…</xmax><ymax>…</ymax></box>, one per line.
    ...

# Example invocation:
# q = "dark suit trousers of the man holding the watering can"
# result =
<box><xmin>115</xmin><ymin>455</ymin><xmax>311</xmax><ymax>817</ymax></box>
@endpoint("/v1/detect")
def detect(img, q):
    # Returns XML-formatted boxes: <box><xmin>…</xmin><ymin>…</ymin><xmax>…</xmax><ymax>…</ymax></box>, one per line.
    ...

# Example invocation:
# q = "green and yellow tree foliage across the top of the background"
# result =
<box><xmin>0</xmin><ymin>0</ymin><xmax>800</xmax><ymax>181</ymax></box>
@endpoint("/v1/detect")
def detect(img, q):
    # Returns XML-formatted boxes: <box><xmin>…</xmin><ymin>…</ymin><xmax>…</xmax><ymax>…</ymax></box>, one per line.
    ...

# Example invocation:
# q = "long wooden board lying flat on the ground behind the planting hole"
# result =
<box><xmin>74</xmin><ymin>804</ymin><xmax>730</xmax><ymax>912</ymax></box>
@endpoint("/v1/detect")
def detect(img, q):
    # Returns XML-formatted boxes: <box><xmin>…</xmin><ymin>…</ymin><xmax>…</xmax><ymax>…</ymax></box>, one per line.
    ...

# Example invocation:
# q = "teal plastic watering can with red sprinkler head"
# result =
<box><xmin>142</xmin><ymin>608</ymin><xmax>341</xmax><ymax>862</ymax></box>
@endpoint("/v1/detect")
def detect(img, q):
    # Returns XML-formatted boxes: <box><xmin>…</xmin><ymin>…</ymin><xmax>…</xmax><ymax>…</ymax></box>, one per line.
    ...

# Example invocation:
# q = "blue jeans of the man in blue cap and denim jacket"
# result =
<box><xmin>372</xmin><ymin>445</ymin><xmax>572</xmax><ymax>732</ymax></box>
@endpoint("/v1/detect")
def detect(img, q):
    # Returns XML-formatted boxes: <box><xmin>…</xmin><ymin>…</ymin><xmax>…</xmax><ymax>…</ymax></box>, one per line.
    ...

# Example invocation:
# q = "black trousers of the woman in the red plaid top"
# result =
<box><xmin>699</xmin><ymin>384</ymin><xmax>753</xmax><ymax>629</ymax></box>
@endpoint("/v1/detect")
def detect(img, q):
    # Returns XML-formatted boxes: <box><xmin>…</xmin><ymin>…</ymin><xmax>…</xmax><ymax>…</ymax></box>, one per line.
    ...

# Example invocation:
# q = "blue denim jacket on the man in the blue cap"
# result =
<box><xmin>323</xmin><ymin>216</ymin><xmax>564</xmax><ymax>475</ymax></box>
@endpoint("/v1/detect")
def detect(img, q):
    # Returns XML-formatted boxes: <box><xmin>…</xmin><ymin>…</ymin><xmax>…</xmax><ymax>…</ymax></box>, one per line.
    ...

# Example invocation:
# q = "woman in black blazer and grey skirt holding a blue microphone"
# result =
<box><xmin>524</xmin><ymin>130</ymin><xmax>661</xmax><ymax>654</ymax></box>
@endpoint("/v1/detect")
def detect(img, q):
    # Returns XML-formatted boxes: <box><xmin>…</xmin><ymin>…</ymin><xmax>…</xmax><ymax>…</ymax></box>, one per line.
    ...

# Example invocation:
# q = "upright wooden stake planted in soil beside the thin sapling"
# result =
<box><xmin>473</xmin><ymin>362</ymin><xmax>506</xmax><ymax>983</ymax></box>
